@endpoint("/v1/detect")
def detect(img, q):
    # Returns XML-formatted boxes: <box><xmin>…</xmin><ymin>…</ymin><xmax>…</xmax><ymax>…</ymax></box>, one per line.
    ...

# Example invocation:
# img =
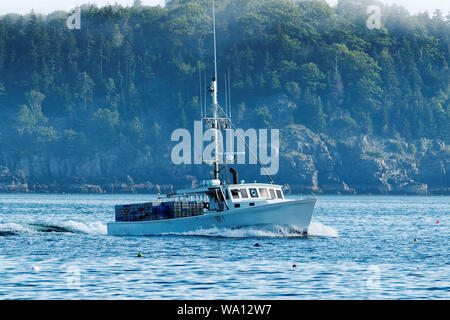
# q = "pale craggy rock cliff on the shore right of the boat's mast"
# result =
<box><xmin>280</xmin><ymin>126</ymin><xmax>450</xmax><ymax>195</ymax></box>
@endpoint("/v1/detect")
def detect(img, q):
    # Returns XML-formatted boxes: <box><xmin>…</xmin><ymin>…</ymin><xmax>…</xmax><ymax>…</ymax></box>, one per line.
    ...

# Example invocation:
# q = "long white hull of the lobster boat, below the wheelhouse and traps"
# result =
<box><xmin>108</xmin><ymin>199</ymin><xmax>317</xmax><ymax>236</ymax></box>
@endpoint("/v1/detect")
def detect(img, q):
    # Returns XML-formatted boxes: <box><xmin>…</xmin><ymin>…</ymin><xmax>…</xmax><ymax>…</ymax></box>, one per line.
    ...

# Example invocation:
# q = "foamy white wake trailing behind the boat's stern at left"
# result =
<box><xmin>0</xmin><ymin>220</ymin><xmax>107</xmax><ymax>236</ymax></box>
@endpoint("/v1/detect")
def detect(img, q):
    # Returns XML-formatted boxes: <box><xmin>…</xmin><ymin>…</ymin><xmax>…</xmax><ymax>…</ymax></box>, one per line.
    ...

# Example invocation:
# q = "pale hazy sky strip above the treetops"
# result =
<box><xmin>0</xmin><ymin>0</ymin><xmax>450</xmax><ymax>15</ymax></box>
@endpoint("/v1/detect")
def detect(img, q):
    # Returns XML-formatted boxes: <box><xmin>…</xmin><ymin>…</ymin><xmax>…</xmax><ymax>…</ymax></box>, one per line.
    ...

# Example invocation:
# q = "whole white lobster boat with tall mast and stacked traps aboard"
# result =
<box><xmin>108</xmin><ymin>0</ymin><xmax>317</xmax><ymax>236</ymax></box>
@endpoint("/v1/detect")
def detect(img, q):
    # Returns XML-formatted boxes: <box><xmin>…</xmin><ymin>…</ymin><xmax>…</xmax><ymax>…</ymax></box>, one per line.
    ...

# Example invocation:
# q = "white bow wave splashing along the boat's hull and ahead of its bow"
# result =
<box><xmin>163</xmin><ymin>222</ymin><xmax>339</xmax><ymax>238</ymax></box>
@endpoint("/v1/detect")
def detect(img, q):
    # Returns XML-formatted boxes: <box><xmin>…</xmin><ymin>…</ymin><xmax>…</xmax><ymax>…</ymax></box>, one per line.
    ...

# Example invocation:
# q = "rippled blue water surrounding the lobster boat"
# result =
<box><xmin>0</xmin><ymin>194</ymin><xmax>450</xmax><ymax>299</ymax></box>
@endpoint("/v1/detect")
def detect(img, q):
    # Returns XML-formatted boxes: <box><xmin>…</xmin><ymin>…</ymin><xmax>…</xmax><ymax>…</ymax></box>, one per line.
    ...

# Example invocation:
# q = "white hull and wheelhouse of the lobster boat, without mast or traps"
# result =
<box><xmin>108</xmin><ymin>180</ymin><xmax>317</xmax><ymax>236</ymax></box>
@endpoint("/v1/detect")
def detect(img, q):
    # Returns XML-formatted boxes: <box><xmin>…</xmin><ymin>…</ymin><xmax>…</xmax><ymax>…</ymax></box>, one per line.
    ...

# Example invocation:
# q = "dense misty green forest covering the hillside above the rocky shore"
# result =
<box><xmin>0</xmin><ymin>0</ymin><xmax>450</xmax><ymax>194</ymax></box>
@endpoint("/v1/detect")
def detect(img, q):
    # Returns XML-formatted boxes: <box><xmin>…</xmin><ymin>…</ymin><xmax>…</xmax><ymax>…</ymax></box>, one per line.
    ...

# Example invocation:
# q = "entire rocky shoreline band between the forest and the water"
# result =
<box><xmin>0</xmin><ymin>126</ymin><xmax>450</xmax><ymax>195</ymax></box>
